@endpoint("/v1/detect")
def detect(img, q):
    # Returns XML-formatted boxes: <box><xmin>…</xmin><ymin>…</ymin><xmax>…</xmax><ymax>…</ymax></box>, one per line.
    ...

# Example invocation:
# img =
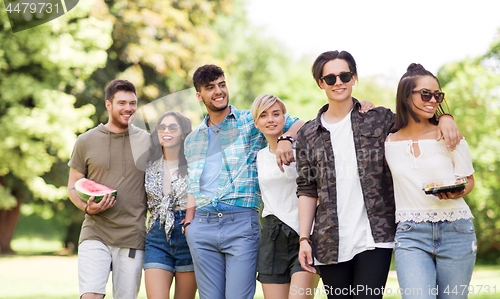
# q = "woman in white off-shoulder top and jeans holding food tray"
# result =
<box><xmin>385</xmin><ymin>64</ymin><xmax>476</xmax><ymax>299</ymax></box>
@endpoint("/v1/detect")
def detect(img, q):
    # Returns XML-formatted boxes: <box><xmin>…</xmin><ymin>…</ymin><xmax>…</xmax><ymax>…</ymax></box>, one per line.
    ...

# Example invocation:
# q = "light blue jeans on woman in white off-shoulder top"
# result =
<box><xmin>394</xmin><ymin>219</ymin><xmax>477</xmax><ymax>299</ymax></box>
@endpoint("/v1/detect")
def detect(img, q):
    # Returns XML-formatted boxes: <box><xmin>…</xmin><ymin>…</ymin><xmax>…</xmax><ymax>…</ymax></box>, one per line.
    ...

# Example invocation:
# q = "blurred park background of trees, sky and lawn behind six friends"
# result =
<box><xmin>0</xmin><ymin>0</ymin><xmax>500</xmax><ymax>298</ymax></box>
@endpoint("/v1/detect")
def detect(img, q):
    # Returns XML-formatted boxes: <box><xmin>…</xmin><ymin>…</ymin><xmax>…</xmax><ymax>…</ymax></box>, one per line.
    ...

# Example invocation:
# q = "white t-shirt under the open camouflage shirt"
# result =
<box><xmin>315</xmin><ymin>113</ymin><xmax>394</xmax><ymax>264</ymax></box>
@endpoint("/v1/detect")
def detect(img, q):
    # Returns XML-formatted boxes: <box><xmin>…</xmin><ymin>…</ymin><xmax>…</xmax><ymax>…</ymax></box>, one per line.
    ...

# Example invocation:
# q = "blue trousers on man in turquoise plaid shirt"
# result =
<box><xmin>186</xmin><ymin>208</ymin><xmax>260</xmax><ymax>299</ymax></box>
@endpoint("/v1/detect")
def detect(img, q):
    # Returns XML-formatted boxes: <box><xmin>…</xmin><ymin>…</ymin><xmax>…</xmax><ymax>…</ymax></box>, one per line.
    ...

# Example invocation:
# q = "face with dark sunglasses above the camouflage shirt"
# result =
<box><xmin>318</xmin><ymin>59</ymin><xmax>356</xmax><ymax>102</ymax></box>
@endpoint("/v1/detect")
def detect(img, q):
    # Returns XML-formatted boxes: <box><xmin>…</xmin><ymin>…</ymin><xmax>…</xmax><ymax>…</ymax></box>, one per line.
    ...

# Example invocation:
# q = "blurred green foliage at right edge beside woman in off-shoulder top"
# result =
<box><xmin>438</xmin><ymin>31</ymin><xmax>500</xmax><ymax>261</ymax></box>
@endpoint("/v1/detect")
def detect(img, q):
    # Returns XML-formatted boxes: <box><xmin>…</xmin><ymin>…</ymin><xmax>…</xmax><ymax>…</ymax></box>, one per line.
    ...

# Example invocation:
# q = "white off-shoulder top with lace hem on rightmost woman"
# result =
<box><xmin>385</xmin><ymin>137</ymin><xmax>474</xmax><ymax>223</ymax></box>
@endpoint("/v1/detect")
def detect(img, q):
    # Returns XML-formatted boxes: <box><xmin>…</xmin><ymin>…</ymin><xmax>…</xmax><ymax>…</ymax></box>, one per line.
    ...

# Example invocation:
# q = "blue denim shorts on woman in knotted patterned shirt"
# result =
<box><xmin>144</xmin><ymin>210</ymin><xmax>194</xmax><ymax>273</ymax></box>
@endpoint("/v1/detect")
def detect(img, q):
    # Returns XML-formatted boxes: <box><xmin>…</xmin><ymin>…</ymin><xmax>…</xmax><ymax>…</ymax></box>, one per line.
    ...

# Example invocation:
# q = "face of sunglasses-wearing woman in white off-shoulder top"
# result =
<box><xmin>408</xmin><ymin>76</ymin><xmax>439</xmax><ymax>120</ymax></box>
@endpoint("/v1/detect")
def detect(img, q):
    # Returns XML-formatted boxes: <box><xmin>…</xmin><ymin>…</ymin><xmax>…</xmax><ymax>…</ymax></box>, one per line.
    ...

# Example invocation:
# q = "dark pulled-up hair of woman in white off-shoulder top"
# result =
<box><xmin>393</xmin><ymin>63</ymin><xmax>446</xmax><ymax>131</ymax></box>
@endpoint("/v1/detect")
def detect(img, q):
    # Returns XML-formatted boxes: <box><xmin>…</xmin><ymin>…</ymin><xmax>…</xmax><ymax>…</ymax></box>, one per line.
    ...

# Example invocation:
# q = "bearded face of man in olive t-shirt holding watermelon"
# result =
<box><xmin>106</xmin><ymin>90</ymin><xmax>137</xmax><ymax>130</ymax></box>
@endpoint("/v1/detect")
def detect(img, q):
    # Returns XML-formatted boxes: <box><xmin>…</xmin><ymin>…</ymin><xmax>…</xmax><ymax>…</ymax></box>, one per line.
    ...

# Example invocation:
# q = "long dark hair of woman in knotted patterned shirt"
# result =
<box><xmin>150</xmin><ymin>111</ymin><xmax>192</xmax><ymax>177</ymax></box>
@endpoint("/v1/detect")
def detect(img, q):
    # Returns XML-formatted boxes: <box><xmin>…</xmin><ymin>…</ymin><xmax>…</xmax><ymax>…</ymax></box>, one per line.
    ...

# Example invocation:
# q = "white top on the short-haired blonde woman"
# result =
<box><xmin>257</xmin><ymin>146</ymin><xmax>299</xmax><ymax>234</ymax></box>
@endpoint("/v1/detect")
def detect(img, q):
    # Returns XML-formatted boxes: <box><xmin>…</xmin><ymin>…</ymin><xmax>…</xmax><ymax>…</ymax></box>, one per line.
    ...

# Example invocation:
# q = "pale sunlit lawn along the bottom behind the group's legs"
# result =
<box><xmin>0</xmin><ymin>255</ymin><xmax>500</xmax><ymax>299</ymax></box>
